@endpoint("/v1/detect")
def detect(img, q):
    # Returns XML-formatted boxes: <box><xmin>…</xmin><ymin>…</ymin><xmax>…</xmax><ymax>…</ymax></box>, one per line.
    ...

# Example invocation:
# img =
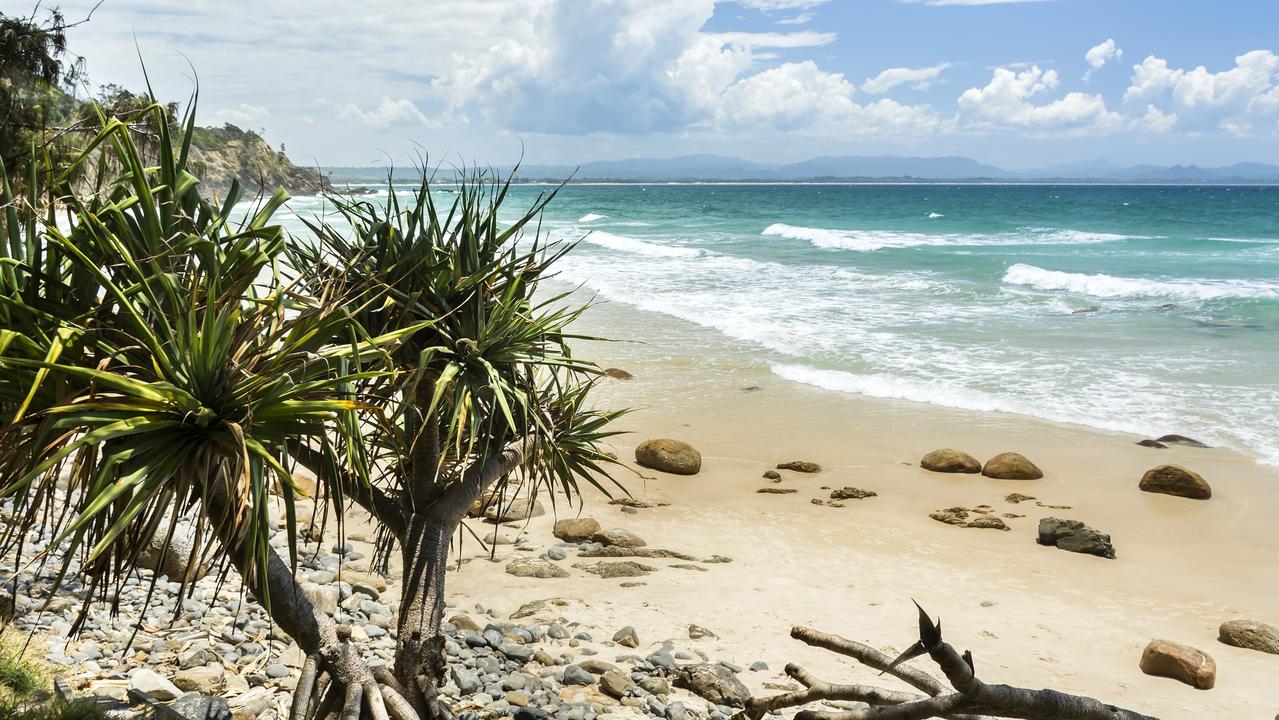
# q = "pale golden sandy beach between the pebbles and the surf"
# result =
<box><xmin>439</xmin><ymin>301</ymin><xmax>1279</xmax><ymax>719</ymax></box>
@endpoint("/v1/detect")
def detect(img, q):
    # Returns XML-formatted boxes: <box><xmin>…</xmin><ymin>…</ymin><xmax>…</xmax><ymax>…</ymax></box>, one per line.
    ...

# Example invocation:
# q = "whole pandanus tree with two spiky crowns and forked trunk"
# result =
<box><xmin>0</xmin><ymin>98</ymin><xmax>615</xmax><ymax>720</ymax></box>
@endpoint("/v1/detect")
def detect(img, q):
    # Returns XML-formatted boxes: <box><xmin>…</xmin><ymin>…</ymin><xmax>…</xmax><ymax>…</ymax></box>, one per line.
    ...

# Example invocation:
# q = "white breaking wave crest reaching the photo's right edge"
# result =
<box><xmin>1004</xmin><ymin>262</ymin><xmax>1279</xmax><ymax>301</ymax></box>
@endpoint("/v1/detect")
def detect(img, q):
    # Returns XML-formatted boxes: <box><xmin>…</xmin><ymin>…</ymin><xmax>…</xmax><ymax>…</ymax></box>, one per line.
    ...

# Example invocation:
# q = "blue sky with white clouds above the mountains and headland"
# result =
<box><xmin>45</xmin><ymin>0</ymin><xmax>1279</xmax><ymax>170</ymax></box>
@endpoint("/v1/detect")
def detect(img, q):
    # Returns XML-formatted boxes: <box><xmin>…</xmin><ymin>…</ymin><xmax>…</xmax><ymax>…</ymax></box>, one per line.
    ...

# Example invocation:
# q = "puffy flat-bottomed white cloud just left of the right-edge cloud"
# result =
<box><xmin>958</xmin><ymin>65</ymin><xmax>1122</xmax><ymax>134</ymax></box>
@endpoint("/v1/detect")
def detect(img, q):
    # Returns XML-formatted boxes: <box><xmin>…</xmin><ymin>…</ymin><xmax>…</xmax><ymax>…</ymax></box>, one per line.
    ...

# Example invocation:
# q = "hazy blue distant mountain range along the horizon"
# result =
<box><xmin>322</xmin><ymin>155</ymin><xmax>1279</xmax><ymax>184</ymax></box>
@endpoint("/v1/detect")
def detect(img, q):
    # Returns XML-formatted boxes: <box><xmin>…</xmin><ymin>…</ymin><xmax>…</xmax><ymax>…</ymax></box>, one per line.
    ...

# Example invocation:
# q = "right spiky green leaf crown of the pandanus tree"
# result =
<box><xmin>290</xmin><ymin>174</ymin><xmax>620</xmax><ymax>519</ymax></box>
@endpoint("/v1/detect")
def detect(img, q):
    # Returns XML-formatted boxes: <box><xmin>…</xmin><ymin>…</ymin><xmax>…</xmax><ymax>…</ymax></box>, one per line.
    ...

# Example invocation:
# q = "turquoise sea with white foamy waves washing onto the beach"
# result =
<box><xmin>282</xmin><ymin>184</ymin><xmax>1279</xmax><ymax>463</ymax></box>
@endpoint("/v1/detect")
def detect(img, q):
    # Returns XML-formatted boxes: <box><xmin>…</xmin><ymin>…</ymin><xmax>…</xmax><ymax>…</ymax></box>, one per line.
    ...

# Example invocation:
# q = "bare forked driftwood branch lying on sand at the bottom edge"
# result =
<box><xmin>734</xmin><ymin>604</ymin><xmax>1157</xmax><ymax>720</ymax></box>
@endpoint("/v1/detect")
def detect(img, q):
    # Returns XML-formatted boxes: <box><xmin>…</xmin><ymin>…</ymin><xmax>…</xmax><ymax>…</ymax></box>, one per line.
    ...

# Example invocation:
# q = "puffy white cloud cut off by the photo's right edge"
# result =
<box><xmin>1124</xmin><ymin>50</ymin><xmax>1279</xmax><ymax>134</ymax></box>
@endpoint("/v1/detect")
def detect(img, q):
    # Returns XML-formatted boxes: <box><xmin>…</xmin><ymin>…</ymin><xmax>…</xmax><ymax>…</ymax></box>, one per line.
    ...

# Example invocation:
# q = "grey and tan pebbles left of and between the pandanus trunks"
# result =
<box><xmin>0</xmin><ymin>496</ymin><xmax>395</xmax><ymax>720</ymax></box>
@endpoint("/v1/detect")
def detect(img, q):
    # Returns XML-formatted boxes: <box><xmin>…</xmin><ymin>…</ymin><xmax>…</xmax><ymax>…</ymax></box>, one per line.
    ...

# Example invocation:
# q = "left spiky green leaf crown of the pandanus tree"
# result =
<box><xmin>0</xmin><ymin>94</ymin><xmax>399</xmax><ymax>626</ymax></box>
